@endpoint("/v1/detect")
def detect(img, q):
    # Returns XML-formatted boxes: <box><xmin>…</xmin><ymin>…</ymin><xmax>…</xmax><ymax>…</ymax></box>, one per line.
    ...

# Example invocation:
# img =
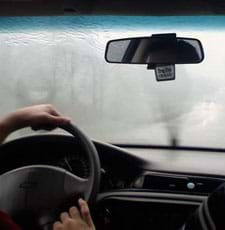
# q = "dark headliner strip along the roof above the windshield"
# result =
<box><xmin>0</xmin><ymin>0</ymin><xmax>225</xmax><ymax>16</ymax></box>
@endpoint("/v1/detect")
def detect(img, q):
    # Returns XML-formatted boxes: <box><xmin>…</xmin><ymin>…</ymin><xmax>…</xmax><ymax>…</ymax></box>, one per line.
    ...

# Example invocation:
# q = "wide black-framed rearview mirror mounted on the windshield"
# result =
<box><xmin>105</xmin><ymin>36</ymin><xmax>204</xmax><ymax>65</ymax></box>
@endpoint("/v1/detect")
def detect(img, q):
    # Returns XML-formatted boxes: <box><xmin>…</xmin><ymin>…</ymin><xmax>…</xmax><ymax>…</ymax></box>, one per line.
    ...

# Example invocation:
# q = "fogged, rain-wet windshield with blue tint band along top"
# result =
<box><xmin>0</xmin><ymin>16</ymin><xmax>225</xmax><ymax>147</ymax></box>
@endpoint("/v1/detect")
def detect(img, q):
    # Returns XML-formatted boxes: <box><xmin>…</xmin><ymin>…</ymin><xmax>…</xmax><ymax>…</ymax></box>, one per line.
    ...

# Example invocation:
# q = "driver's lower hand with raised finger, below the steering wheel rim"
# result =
<box><xmin>53</xmin><ymin>199</ymin><xmax>95</xmax><ymax>230</ymax></box>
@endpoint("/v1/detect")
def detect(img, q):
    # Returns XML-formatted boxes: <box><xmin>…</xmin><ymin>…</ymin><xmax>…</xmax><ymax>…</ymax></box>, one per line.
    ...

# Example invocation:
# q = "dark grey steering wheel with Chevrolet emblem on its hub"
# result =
<box><xmin>0</xmin><ymin>124</ymin><xmax>100</xmax><ymax>229</ymax></box>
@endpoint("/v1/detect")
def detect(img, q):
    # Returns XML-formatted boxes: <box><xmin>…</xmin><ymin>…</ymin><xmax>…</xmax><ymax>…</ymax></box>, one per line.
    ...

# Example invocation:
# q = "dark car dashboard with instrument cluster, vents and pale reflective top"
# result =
<box><xmin>0</xmin><ymin>135</ymin><xmax>225</xmax><ymax>230</ymax></box>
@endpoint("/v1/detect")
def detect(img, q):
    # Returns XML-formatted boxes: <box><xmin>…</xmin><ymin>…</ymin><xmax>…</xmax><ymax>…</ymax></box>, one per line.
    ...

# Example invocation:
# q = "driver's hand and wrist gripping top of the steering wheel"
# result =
<box><xmin>0</xmin><ymin>104</ymin><xmax>70</xmax><ymax>143</ymax></box>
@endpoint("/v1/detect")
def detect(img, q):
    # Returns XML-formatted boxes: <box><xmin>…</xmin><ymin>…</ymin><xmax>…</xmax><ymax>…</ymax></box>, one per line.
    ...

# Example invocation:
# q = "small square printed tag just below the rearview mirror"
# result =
<box><xmin>155</xmin><ymin>65</ymin><xmax>175</xmax><ymax>81</ymax></box>
